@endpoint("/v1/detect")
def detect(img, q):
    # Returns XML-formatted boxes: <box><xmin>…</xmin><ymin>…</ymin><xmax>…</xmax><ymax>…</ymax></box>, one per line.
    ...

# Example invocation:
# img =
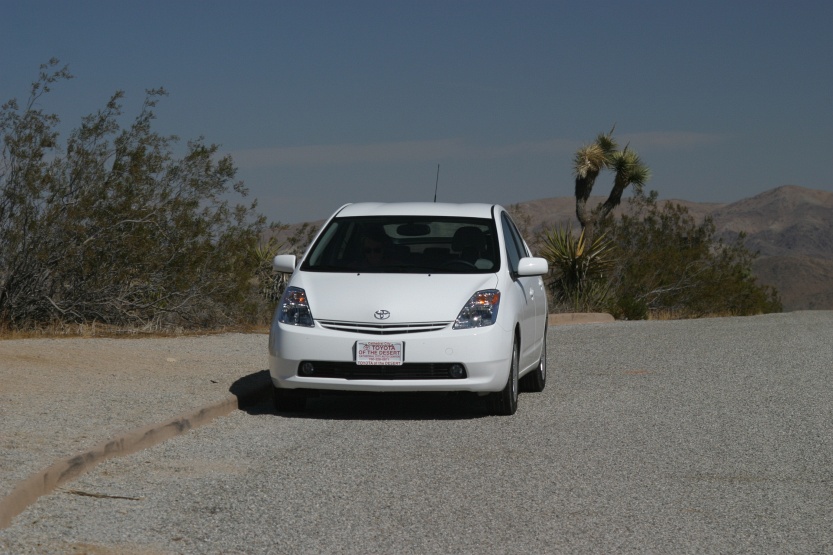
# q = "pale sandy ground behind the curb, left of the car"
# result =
<box><xmin>0</xmin><ymin>334</ymin><xmax>268</xmax><ymax>504</ymax></box>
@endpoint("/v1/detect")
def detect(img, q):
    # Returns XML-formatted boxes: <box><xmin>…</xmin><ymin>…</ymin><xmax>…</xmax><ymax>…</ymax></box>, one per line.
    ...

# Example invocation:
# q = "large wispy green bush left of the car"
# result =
<box><xmin>0</xmin><ymin>60</ymin><xmax>263</xmax><ymax>329</ymax></box>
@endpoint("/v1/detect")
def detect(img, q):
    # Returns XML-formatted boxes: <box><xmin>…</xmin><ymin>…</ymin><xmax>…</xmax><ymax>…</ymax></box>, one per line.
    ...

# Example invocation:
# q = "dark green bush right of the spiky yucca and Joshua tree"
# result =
<box><xmin>603</xmin><ymin>192</ymin><xmax>781</xmax><ymax>319</ymax></box>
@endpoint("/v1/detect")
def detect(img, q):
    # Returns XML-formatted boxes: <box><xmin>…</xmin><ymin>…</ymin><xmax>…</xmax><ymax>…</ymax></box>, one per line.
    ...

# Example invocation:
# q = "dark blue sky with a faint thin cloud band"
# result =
<box><xmin>0</xmin><ymin>0</ymin><xmax>833</xmax><ymax>223</ymax></box>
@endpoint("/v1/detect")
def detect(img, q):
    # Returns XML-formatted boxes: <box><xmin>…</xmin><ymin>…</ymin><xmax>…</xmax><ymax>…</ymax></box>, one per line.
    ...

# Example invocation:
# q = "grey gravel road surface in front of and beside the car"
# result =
<box><xmin>0</xmin><ymin>312</ymin><xmax>833</xmax><ymax>554</ymax></box>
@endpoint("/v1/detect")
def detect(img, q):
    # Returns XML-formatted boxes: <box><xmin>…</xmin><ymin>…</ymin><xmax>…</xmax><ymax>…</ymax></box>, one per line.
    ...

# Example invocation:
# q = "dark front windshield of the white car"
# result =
<box><xmin>301</xmin><ymin>216</ymin><xmax>500</xmax><ymax>274</ymax></box>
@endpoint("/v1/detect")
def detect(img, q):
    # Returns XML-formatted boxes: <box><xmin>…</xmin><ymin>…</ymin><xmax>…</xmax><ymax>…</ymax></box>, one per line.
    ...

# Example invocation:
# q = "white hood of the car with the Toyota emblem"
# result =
<box><xmin>291</xmin><ymin>272</ymin><xmax>498</xmax><ymax>324</ymax></box>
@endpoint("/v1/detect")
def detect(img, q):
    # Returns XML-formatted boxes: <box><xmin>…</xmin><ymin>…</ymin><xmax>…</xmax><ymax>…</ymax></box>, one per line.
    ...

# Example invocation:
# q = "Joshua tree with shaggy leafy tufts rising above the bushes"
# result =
<box><xmin>573</xmin><ymin>129</ymin><xmax>650</xmax><ymax>244</ymax></box>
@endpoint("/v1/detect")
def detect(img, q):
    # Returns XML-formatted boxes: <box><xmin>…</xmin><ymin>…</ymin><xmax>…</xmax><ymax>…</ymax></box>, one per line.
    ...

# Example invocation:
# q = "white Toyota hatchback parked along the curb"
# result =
<box><xmin>269</xmin><ymin>203</ymin><xmax>547</xmax><ymax>415</ymax></box>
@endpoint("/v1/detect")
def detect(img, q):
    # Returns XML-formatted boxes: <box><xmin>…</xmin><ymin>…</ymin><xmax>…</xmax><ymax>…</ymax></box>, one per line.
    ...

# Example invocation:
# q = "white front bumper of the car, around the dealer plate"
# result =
<box><xmin>269</xmin><ymin>323</ymin><xmax>513</xmax><ymax>393</ymax></box>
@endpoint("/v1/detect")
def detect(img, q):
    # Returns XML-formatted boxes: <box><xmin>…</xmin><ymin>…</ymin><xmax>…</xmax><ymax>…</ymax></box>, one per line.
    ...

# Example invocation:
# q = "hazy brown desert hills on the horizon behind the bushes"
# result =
<box><xmin>270</xmin><ymin>185</ymin><xmax>833</xmax><ymax>311</ymax></box>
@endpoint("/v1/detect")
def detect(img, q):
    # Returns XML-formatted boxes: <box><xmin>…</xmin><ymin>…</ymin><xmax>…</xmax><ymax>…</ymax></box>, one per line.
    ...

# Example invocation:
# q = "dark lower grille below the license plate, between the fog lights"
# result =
<box><xmin>298</xmin><ymin>361</ymin><xmax>466</xmax><ymax>380</ymax></box>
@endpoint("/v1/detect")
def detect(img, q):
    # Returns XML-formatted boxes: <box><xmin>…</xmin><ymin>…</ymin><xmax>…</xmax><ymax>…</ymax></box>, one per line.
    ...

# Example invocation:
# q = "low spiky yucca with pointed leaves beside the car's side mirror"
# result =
<box><xmin>540</xmin><ymin>226</ymin><xmax>613</xmax><ymax>312</ymax></box>
